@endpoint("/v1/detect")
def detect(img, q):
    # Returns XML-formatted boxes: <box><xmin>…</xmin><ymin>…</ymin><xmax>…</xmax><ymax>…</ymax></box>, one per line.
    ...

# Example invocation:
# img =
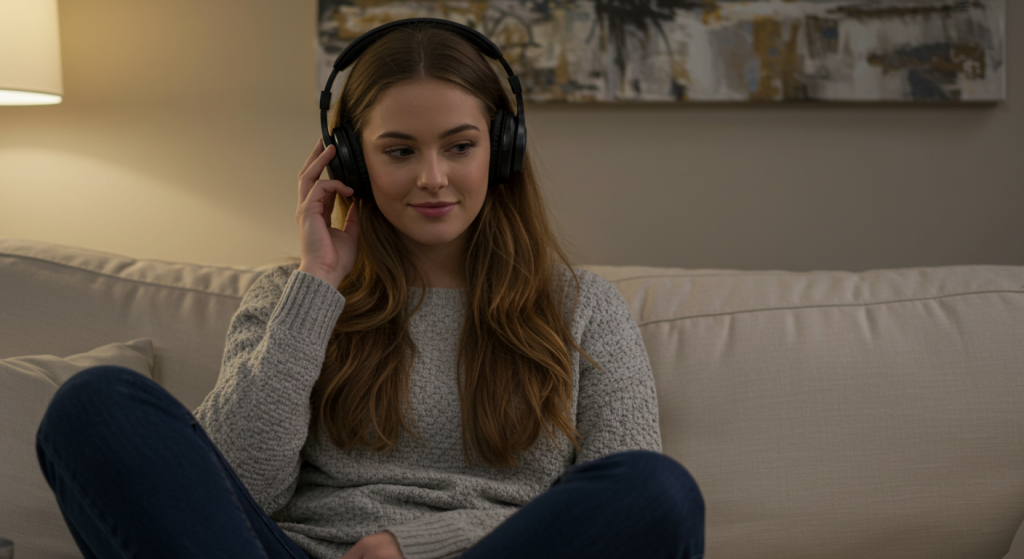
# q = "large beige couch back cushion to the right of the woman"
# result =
<box><xmin>588</xmin><ymin>266</ymin><xmax>1024</xmax><ymax>559</ymax></box>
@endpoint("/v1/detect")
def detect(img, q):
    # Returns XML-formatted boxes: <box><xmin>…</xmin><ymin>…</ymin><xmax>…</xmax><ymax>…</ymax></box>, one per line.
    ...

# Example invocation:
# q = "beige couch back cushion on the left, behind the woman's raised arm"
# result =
<box><xmin>0</xmin><ymin>239</ymin><xmax>272</xmax><ymax>410</ymax></box>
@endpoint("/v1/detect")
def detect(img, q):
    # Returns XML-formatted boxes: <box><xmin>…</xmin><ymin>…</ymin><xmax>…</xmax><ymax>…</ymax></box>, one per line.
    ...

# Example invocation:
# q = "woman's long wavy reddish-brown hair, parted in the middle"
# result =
<box><xmin>309</xmin><ymin>22</ymin><xmax>599</xmax><ymax>467</ymax></box>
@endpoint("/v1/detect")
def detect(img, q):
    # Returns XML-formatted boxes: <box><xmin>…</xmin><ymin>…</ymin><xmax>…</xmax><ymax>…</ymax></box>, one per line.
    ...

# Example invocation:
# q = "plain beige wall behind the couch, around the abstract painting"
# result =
<box><xmin>0</xmin><ymin>0</ymin><xmax>1024</xmax><ymax>270</ymax></box>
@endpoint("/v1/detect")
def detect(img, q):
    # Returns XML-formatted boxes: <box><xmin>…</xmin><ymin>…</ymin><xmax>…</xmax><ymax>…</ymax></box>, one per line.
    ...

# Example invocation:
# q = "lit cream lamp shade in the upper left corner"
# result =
<box><xmin>0</xmin><ymin>0</ymin><xmax>63</xmax><ymax>104</ymax></box>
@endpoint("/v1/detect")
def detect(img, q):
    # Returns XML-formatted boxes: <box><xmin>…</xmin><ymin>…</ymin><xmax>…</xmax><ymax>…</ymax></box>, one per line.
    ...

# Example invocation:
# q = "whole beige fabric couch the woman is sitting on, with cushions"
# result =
<box><xmin>0</xmin><ymin>239</ymin><xmax>1024</xmax><ymax>559</ymax></box>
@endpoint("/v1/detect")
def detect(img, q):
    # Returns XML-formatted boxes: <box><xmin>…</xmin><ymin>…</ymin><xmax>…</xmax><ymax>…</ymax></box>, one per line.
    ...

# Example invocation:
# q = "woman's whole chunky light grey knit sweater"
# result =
<box><xmin>195</xmin><ymin>263</ymin><xmax>662</xmax><ymax>559</ymax></box>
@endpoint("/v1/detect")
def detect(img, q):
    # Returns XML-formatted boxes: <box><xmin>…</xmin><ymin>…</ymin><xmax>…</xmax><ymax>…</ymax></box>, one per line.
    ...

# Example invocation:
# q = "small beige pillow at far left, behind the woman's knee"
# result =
<box><xmin>0</xmin><ymin>339</ymin><xmax>153</xmax><ymax>559</ymax></box>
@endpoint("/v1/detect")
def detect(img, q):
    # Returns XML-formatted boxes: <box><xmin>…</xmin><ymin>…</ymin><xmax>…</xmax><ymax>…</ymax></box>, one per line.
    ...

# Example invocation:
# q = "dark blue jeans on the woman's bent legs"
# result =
<box><xmin>36</xmin><ymin>367</ymin><xmax>705</xmax><ymax>559</ymax></box>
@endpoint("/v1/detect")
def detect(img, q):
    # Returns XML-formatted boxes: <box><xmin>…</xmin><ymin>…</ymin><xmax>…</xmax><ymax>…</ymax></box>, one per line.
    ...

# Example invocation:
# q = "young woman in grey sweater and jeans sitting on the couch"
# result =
<box><xmin>37</xmin><ymin>17</ymin><xmax>703</xmax><ymax>559</ymax></box>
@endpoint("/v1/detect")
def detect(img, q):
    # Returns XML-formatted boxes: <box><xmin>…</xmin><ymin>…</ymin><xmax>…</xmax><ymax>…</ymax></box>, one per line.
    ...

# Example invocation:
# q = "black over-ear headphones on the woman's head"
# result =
<box><xmin>319</xmin><ymin>17</ymin><xmax>526</xmax><ymax>200</ymax></box>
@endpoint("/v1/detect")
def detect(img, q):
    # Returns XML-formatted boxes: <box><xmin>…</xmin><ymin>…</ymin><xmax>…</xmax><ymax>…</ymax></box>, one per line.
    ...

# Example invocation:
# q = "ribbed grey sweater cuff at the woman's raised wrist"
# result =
<box><xmin>270</xmin><ymin>270</ymin><xmax>345</xmax><ymax>340</ymax></box>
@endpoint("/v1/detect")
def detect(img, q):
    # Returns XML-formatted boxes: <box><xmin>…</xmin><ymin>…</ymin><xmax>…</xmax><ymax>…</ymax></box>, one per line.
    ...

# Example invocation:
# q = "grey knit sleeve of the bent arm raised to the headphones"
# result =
<box><xmin>186</xmin><ymin>264</ymin><xmax>345</xmax><ymax>514</ymax></box>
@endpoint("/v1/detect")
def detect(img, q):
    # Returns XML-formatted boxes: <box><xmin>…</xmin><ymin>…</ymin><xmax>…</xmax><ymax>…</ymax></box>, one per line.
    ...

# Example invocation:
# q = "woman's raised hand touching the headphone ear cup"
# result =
<box><xmin>295</xmin><ymin>139</ymin><xmax>359</xmax><ymax>287</ymax></box>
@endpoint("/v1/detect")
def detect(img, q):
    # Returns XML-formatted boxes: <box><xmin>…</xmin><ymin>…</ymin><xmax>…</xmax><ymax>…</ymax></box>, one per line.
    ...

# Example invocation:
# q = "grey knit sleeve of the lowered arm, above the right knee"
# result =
<box><xmin>573</xmin><ymin>270</ymin><xmax>662</xmax><ymax>464</ymax></box>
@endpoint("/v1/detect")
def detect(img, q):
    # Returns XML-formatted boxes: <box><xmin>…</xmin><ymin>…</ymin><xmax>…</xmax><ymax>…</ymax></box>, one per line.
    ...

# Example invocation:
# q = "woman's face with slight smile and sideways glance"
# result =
<box><xmin>361</xmin><ymin>78</ymin><xmax>490</xmax><ymax>252</ymax></box>
